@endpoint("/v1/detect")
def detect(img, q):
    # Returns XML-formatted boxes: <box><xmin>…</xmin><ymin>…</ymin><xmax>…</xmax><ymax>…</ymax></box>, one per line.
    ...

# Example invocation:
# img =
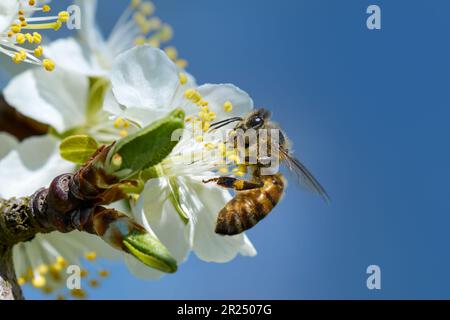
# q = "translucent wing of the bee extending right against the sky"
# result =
<box><xmin>279</xmin><ymin>147</ymin><xmax>330</xmax><ymax>203</ymax></box>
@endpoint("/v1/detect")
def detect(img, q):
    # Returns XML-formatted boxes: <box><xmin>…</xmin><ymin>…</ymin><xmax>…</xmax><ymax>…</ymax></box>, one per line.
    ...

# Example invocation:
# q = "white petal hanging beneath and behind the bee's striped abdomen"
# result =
<box><xmin>186</xmin><ymin>180</ymin><xmax>256</xmax><ymax>262</ymax></box>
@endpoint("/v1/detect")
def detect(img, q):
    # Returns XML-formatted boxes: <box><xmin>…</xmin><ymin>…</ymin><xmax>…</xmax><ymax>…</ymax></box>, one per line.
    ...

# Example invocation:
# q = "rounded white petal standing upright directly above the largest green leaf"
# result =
<box><xmin>111</xmin><ymin>45</ymin><xmax>180</xmax><ymax>111</ymax></box>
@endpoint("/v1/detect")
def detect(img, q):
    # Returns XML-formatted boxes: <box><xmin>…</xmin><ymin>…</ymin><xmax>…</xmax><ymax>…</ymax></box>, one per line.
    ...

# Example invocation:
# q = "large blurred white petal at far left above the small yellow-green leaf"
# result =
<box><xmin>3</xmin><ymin>69</ymin><xmax>89</xmax><ymax>132</ymax></box>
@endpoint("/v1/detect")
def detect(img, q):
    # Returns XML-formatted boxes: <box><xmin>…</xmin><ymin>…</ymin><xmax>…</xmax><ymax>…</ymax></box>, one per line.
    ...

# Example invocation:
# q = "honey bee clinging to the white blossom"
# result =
<box><xmin>203</xmin><ymin>109</ymin><xmax>330</xmax><ymax>235</ymax></box>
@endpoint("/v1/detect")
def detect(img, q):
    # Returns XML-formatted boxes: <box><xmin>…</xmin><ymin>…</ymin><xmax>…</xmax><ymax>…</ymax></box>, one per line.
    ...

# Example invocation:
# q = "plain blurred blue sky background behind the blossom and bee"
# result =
<box><xmin>3</xmin><ymin>0</ymin><xmax>450</xmax><ymax>299</ymax></box>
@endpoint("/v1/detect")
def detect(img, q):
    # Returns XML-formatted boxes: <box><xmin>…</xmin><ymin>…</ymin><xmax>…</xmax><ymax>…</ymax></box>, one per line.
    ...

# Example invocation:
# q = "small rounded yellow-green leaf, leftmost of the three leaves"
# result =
<box><xmin>59</xmin><ymin>135</ymin><xmax>98</xmax><ymax>164</ymax></box>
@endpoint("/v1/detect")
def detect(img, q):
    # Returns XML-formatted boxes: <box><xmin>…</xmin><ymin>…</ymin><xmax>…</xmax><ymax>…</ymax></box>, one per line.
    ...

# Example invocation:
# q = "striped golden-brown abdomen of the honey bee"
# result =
<box><xmin>216</xmin><ymin>174</ymin><xmax>284</xmax><ymax>235</ymax></box>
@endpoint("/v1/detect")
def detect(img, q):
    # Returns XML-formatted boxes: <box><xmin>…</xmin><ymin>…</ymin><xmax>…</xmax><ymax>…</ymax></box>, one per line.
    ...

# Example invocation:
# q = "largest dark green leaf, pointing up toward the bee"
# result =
<box><xmin>106</xmin><ymin>109</ymin><xmax>184</xmax><ymax>179</ymax></box>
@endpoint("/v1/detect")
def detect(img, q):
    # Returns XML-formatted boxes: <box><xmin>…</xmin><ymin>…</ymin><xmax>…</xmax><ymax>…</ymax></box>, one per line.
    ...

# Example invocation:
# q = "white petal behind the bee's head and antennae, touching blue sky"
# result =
<box><xmin>198</xmin><ymin>84</ymin><xmax>253</xmax><ymax>120</ymax></box>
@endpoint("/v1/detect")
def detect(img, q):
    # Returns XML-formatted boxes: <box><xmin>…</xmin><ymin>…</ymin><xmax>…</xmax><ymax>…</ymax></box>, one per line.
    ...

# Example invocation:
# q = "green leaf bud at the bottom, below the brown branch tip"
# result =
<box><xmin>123</xmin><ymin>231</ymin><xmax>177</xmax><ymax>273</ymax></box>
